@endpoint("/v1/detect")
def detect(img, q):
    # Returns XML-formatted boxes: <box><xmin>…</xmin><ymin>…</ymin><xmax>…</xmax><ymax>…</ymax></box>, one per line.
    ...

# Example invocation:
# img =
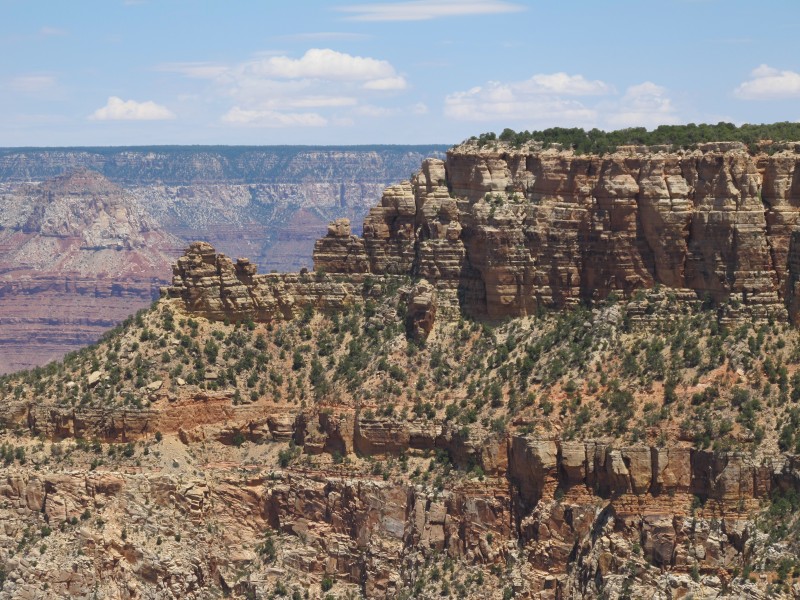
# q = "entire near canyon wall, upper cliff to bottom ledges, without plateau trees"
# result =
<box><xmin>0</xmin><ymin>142</ymin><xmax>800</xmax><ymax>599</ymax></box>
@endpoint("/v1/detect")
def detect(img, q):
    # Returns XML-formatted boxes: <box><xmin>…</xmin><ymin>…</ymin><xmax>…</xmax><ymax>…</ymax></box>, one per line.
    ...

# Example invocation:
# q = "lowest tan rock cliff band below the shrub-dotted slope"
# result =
<box><xmin>0</xmin><ymin>407</ymin><xmax>800</xmax><ymax>599</ymax></box>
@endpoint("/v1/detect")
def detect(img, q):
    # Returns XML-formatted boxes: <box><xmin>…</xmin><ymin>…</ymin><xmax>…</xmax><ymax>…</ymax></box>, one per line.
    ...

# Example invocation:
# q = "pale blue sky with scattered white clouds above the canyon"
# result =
<box><xmin>0</xmin><ymin>0</ymin><xmax>800</xmax><ymax>146</ymax></box>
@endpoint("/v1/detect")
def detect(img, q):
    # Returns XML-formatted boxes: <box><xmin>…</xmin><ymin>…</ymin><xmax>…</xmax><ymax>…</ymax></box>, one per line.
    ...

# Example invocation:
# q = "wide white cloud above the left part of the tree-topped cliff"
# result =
<box><xmin>444</xmin><ymin>73</ymin><xmax>613</xmax><ymax>124</ymax></box>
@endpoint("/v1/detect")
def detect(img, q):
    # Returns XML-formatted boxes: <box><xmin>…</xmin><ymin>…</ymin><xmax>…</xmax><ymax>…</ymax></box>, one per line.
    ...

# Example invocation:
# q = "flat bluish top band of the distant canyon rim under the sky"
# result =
<box><xmin>0</xmin><ymin>144</ymin><xmax>446</xmax><ymax>185</ymax></box>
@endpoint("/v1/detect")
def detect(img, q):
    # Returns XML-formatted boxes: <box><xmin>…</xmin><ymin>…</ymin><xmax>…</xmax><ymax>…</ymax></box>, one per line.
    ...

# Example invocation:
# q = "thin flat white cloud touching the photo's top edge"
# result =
<box><xmin>337</xmin><ymin>0</ymin><xmax>526</xmax><ymax>21</ymax></box>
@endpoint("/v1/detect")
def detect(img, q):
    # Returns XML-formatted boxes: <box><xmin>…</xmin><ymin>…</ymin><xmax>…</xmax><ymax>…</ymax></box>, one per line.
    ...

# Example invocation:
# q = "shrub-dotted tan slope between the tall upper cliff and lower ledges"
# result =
<box><xmin>6</xmin><ymin>279</ymin><xmax>800</xmax><ymax>452</ymax></box>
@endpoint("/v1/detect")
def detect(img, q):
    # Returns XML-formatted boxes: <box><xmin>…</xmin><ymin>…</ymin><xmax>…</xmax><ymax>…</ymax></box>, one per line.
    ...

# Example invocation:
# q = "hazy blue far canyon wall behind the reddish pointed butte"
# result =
<box><xmin>0</xmin><ymin>145</ymin><xmax>446</xmax><ymax>271</ymax></box>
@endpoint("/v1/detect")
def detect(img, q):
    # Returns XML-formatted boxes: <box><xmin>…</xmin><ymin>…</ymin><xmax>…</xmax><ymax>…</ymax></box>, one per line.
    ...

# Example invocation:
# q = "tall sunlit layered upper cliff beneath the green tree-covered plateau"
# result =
<box><xmin>314</xmin><ymin>143</ymin><xmax>800</xmax><ymax>320</ymax></box>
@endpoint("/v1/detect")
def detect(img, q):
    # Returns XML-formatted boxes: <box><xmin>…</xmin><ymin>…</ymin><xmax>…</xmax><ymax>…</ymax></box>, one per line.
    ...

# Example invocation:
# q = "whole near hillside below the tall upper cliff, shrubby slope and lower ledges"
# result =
<box><xmin>2</xmin><ymin>258</ymin><xmax>800</xmax><ymax>597</ymax></box>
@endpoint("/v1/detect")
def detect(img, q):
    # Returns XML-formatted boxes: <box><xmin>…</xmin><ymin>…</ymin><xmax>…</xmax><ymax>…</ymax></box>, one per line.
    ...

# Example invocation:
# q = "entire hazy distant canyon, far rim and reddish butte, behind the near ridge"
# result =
<box><xmin>0</xmin><ymin>146</ymin><xmax>444</xmax><ymax>372</ymax></box>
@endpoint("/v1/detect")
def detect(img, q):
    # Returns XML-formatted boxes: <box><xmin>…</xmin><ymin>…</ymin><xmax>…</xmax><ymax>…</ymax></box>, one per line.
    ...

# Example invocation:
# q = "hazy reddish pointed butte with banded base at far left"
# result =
<box><xmin>0</xmin><ymin>170</ymin><xmax>181</xmax><ymax>372</ymax></box>
